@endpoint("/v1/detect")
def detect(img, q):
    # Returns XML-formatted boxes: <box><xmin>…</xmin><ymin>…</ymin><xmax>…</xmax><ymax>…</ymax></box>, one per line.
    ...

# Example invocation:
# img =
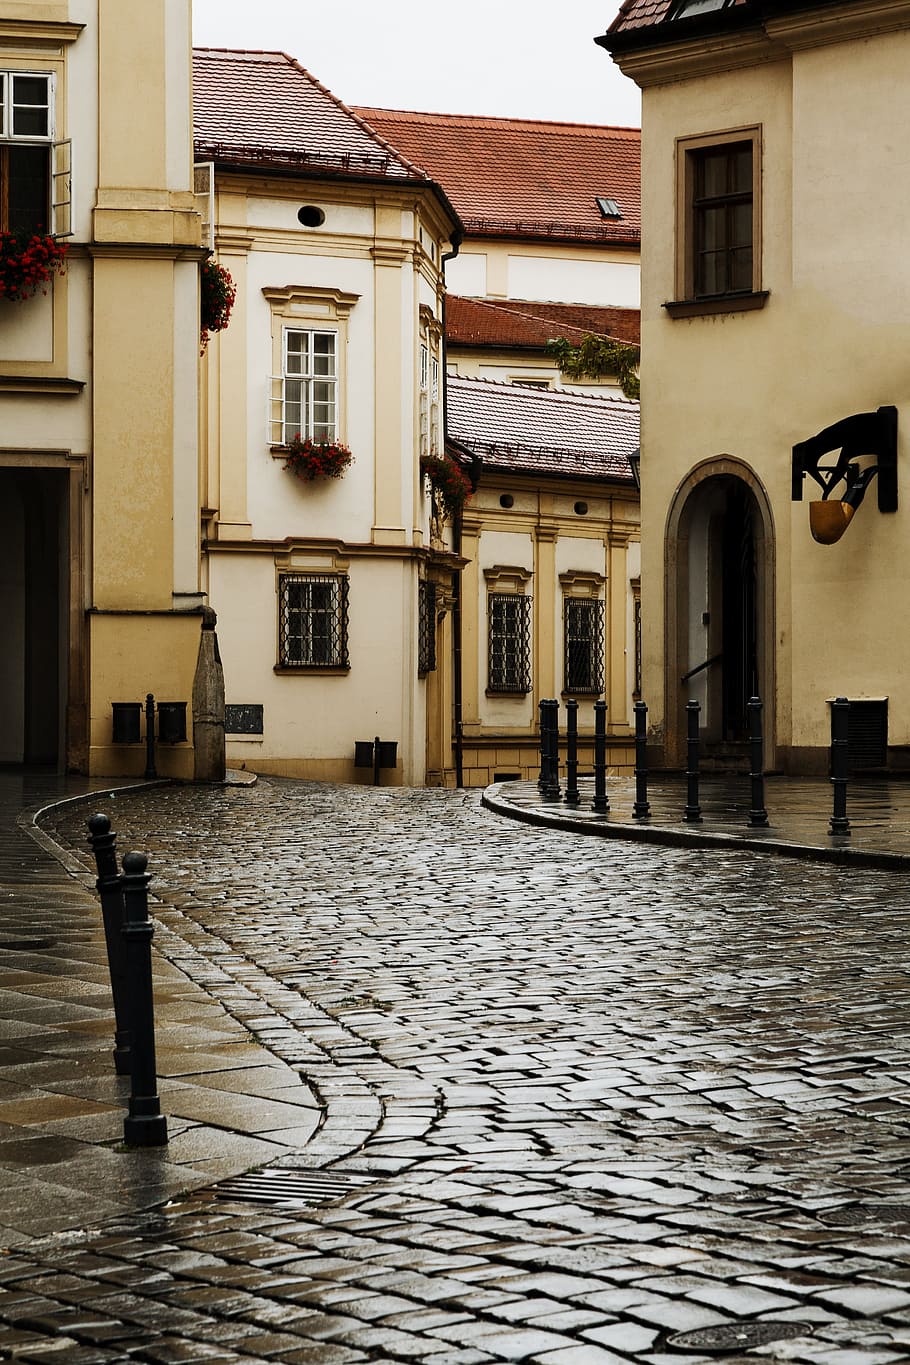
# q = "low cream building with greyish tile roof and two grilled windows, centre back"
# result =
<box><xmin>447</xmin><ymin>377</ymin><xmax>640</xmax><ymax>786</ymax></box>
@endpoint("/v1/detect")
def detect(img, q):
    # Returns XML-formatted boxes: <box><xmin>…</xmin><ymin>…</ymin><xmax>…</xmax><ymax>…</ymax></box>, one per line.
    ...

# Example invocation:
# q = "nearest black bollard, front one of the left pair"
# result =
<box><xmin>123</xmin><ymin>853</ymin><xmax>168</xmax><ymax>1147</ymax></box>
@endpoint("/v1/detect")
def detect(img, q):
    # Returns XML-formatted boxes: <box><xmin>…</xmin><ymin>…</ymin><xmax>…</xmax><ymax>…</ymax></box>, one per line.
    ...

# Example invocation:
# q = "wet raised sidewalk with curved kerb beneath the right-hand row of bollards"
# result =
<box><xmin>483</xmin><ymin>774</ymin><xmax>910</xmax><ymax>868</ymax></box>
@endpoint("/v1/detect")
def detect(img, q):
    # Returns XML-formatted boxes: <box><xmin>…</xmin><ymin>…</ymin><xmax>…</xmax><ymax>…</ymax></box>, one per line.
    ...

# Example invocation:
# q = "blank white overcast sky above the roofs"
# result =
<box><xmin>192</xmin><ymin>0</ymin><xmax>641</xmax><ymax>127</ymax></box>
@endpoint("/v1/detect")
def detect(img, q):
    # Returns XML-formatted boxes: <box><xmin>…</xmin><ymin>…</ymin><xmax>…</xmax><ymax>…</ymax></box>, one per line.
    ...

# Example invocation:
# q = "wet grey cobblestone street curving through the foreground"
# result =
<box><xmin>0</xmin><ymin>779</ymin><xmax>910</xmax><ymax>1365</ymax></box>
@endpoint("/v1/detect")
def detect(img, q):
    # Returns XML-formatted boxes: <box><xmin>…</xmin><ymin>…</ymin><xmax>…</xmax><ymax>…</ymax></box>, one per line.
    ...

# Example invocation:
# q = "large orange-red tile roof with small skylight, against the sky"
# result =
<box><xmin>356</xmin><ymin>108</ymin><xmax>641</xmax><ymax>246</ymax></box>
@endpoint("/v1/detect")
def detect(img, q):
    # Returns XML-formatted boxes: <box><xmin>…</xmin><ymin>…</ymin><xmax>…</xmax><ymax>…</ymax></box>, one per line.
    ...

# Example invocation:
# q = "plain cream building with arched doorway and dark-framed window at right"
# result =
<box><xmin>603</xmin><ymin>0</ymin><xmax>910</xmax><ymax>773</ymax></box>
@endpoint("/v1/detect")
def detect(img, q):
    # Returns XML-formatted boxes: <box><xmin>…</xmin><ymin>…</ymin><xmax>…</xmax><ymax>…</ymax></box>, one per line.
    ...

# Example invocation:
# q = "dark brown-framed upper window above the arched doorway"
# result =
<box><xmin>666</xmin><ymin>128</ymin><xmax>765</xmax><ymax>314</ymax></box>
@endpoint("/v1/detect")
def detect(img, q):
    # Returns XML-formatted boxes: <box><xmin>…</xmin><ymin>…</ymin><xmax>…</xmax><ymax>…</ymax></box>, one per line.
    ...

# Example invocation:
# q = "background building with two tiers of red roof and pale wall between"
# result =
<box><xmin>357</xmin><ymin>109</ymin><xmax>641</xmax><ymax>393</ymax></box>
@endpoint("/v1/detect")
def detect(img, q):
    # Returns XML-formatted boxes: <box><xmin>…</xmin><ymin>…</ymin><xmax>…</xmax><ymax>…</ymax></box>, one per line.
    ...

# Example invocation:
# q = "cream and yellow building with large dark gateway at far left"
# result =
<box><xmin>0</xmin><ymin>0</ymin><xmax>203</xmax><ymax>775</ymax></box>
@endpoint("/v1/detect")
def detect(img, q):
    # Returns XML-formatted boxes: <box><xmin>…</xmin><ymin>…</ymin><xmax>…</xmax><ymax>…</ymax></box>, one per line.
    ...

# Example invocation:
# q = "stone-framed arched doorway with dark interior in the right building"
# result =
<box><xmin>667</xmin><ymin>457</ymin><xmax>774</xmax><ymax>766</ymax></box>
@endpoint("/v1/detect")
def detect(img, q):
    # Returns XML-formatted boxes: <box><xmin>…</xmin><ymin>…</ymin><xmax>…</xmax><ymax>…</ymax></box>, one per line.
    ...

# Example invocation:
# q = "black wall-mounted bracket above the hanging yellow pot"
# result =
<box><xmin>793</xmin><ymin>407</ymin><xmax>898</xmax><ymax>512</ymax></box>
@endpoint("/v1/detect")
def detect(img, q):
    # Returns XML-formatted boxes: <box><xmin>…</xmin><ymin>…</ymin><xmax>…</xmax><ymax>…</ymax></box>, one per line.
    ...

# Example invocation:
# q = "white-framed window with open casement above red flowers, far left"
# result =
<box><xmin>0</xmin><ymin>71</ymin><xmax>71</xmax><ymax>236</ymax></box>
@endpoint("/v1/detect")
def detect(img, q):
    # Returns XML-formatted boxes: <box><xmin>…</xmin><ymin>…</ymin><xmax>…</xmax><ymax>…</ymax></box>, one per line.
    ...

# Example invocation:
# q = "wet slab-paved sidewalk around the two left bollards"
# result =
<box><xmin>0</xmin><ymin>774</ymin><xmax>321</xmax><ymax>1246</ymax></box>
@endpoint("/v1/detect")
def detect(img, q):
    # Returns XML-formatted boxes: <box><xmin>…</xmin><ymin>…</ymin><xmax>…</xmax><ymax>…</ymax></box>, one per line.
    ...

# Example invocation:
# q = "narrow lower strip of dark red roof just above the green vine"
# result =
<box><xmin>446</xmin><ymin>293</ymin><xmax>641</xmax><ymax>351</ymax></box>
